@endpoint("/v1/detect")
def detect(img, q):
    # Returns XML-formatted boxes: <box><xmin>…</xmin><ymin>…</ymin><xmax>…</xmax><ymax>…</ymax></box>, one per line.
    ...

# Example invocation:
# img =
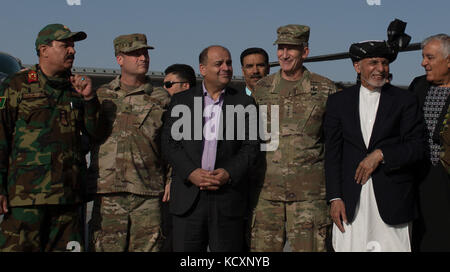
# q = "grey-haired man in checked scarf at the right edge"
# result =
<box><xmin>409</xmin><ymin>34</ymin><xmax>450</xmax><ymax>251</ymax></box>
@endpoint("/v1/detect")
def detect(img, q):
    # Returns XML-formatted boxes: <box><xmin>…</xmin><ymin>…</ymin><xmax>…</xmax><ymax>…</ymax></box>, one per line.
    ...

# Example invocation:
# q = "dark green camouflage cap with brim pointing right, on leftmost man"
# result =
<box><xmin>35</xmin><ymin>24</ymin><xmax>87</xmax><ymax>50</ymax></box>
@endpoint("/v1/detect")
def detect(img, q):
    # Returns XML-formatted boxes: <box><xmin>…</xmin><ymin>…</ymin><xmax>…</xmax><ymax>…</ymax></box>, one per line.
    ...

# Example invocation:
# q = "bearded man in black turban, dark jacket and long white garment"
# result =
<box><xmin>325</xmin><ymin>41</ymin><xmax>424</xmax><ymax>251</ymax></box>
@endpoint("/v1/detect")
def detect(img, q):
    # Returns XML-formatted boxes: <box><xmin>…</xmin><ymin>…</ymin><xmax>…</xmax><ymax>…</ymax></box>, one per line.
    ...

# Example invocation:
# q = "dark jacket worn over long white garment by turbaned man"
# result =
<box><xmin>324</xmin><ymin>84</ymin><xmax>425</xmax><ymax>225</ymax></box>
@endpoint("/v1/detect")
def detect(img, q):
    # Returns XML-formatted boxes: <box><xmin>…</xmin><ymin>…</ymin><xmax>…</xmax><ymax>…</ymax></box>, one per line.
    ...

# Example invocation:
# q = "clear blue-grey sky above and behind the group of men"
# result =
<box><xmin>0</xmin><ymin>0</ymin><xmax>450</xmax><ymax>85</ymax></box>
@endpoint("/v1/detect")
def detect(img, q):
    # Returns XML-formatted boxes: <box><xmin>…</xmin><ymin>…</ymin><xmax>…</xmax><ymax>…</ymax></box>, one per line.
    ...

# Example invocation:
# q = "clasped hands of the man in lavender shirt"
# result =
<box><xmin>188</xmin><ymin>168</ymin><xmax>230</xmax><ymax>191</ymax></box>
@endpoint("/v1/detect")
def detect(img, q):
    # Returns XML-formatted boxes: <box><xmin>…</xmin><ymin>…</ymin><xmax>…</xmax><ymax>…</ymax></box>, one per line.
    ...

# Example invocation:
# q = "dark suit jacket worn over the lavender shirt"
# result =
<box><xmin>162</xmin><ymin>84</ymin><xmax>259</xmax><ymax>216</ymax></box>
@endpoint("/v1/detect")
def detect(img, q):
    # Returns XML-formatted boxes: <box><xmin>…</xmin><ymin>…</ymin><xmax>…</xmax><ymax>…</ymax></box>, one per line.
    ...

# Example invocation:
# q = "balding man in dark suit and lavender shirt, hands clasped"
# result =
<box><xmin>162</xmin><ymin>46</ymin><xmax>259</xmax><ymax>251</ymax></box>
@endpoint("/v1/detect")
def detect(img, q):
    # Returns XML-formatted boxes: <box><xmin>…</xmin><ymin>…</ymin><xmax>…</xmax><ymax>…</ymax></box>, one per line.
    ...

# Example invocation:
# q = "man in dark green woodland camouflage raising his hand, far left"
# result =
<box><xmin>0</xmin><ymin>24</ymin><xmax>100</xmax><ymax>251</ymax></box>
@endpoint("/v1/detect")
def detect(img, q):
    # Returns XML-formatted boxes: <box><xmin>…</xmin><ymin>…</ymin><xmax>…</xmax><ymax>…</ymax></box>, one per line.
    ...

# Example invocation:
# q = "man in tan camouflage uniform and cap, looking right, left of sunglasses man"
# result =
<box><xmin>90</xmin><ymin>34</ymin><xmax>170</xmax><ymax>251</ymax></box>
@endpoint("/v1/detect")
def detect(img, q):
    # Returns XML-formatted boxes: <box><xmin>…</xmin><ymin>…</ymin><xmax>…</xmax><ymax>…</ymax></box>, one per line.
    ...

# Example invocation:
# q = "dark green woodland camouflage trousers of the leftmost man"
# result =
<box><xmin>0</xmin><ymin>205</ymin><xmax>84</xmax><ymax>252</ymax></box>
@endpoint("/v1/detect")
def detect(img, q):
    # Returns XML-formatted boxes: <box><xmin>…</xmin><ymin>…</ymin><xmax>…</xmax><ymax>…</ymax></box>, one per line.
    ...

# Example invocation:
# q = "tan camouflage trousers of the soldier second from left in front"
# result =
<box><xmin>89</xmin><ymin>193</ymin><xmax>163</xmax><ymax>252</ymax></box>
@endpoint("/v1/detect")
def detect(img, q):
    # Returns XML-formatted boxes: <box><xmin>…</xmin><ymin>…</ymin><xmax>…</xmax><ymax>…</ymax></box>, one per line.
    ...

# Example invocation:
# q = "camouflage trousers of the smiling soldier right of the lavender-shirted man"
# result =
<box><xmin>250</xmin><ymin>199</ymin><xmax>331</xmax><ymax>252</ymax></box>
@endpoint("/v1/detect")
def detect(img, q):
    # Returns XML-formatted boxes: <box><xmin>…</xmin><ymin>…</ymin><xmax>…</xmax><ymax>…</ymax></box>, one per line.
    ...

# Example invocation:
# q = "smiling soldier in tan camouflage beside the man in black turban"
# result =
<box><xmin>251</xmin><ymin>25</ymin><xmax>336</xmax><ymax>251</ymax></box>
